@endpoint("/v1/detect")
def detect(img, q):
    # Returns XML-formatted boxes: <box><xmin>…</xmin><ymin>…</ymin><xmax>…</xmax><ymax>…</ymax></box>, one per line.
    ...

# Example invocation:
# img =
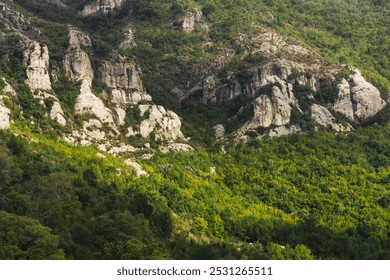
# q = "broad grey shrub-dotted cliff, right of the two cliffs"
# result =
<box><xmin>175</xmin><ymin>27</ymin><xmax>386</xmax><ymax>139</ymax></box>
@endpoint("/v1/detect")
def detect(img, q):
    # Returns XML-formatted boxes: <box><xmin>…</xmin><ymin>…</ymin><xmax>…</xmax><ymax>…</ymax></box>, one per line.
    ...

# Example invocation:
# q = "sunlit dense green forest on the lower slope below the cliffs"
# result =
<box><xmin>0</xmin><ymin>125</ymin><xmax>390</xmax><ymax>259</ymax></box>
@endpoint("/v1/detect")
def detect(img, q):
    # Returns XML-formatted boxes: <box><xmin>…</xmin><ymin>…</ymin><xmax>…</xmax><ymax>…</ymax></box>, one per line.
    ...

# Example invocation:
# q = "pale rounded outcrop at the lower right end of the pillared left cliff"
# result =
<box><xmin>127</xmin><ymin>105</ymin><xmax>184</xmax><ymax>140</ymax></box>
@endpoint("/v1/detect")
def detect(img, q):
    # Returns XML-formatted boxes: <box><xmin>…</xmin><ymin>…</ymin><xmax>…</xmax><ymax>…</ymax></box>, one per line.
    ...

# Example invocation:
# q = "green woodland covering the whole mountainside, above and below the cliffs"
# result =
<box><xmin>0</xmin><ymin>0</ymin><xmax>390</xmax><ymax>259</ymax></box>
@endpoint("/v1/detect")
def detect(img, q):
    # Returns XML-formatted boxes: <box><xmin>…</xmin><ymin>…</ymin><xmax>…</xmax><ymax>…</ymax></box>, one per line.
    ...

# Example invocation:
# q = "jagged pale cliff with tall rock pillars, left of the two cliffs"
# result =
<box><xmin>0</xmin><ymin>1</ymin><xmax>189</xmax><ymax>153</ymax></box>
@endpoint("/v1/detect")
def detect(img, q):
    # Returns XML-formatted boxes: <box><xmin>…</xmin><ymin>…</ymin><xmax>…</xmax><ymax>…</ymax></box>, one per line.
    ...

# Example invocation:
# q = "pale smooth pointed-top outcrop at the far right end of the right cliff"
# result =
<box><xmin>333</xmin><ymin>69</ymin><xmax>386</xmax><ymax>120</ymax></box>
